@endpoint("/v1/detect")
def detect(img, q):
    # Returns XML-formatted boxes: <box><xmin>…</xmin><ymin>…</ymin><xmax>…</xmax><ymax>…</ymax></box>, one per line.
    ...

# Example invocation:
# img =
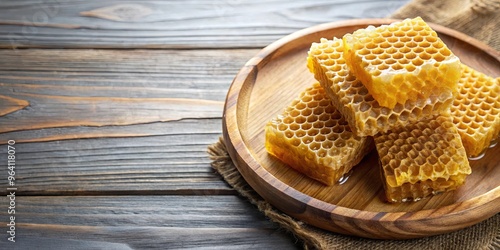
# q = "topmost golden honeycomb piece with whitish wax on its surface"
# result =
<box><xmin>343</xmin><ymin>17</ymin><xmax>460</xmax><ymax>108</ymax></box>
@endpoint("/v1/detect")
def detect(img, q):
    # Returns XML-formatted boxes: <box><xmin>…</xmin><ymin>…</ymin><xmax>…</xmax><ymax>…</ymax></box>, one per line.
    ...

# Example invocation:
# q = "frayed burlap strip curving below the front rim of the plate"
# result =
<box><xmin>208</xmin><ymin>137</ymin><xmax>500</xmax><ymax>250</ymax></box>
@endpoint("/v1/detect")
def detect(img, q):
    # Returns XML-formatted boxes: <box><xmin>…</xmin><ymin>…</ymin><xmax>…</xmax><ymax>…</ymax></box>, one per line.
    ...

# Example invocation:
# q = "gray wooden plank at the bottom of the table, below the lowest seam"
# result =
<box><xmin>0</xmin><ymin>195</ymin><xmax>297</xmax><ymax>249</ymax></box>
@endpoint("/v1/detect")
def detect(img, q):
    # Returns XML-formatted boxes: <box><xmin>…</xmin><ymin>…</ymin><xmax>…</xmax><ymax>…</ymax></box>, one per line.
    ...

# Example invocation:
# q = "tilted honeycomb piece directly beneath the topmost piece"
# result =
<box><xmin>307</xmin><ymin>38</ymin><xmax>453</xmax><ymax>136</ymax></box>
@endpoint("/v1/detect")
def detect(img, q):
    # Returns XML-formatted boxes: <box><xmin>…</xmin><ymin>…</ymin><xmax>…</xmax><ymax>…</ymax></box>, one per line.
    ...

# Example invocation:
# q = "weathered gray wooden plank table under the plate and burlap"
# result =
<box><xmin>0</xmin><ymin>0</ymin><xmax>407</xmax><ymax>249</ymax></box>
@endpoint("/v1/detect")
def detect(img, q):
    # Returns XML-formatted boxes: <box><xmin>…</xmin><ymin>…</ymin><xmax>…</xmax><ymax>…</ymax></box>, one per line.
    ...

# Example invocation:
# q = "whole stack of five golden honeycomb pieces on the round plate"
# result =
<box><xmin>266</xmin><ymin>17</ymin><xmax>494</xmax><ymax>202</ymax></box>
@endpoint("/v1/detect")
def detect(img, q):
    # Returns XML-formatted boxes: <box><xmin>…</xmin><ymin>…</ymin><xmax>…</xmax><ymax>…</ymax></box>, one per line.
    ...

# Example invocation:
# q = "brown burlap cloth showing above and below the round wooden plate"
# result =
<box><xmin>208</xmin><ymin>0</ymin><xmax>500</xmax><ymax>250</ymax></box>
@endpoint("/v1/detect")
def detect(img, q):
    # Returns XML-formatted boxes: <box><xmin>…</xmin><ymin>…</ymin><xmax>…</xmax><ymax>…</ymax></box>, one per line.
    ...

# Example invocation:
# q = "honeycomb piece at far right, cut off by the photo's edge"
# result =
<box><xmin>450</xmin><ymin>65</ymin><xmax>500</xmax><ymax>156</ymax></box>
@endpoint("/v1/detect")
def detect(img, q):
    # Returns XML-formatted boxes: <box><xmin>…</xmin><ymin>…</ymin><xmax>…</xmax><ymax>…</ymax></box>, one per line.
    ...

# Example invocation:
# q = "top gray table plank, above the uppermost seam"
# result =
<box><xmin>0</xmin><ymin>0</ymin><xmax>408</xmax><ymax>48</ymax></box>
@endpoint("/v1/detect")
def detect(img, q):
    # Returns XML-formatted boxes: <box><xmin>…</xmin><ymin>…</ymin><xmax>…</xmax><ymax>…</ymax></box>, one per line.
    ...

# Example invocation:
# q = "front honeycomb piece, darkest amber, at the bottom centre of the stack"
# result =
<box><xmin>374</xmin><ymin>115</ymin><xmax>471</xmax><ymax>202</ymax></box>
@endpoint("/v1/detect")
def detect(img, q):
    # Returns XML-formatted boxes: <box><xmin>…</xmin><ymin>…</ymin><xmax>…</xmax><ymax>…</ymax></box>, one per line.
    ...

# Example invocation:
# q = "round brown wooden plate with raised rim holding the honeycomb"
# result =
<box><xmin>223</xmin><ymin>19</ymin><xmax>500</xmax><ymax>239</ymax></box>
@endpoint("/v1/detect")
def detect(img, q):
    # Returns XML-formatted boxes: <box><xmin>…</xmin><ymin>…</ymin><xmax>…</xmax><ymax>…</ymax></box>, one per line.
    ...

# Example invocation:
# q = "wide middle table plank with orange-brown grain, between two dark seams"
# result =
<box><xmin>0</xmin><ymin>49</ymin><xmax>252</xmax><ymax>195</ymax></box>
